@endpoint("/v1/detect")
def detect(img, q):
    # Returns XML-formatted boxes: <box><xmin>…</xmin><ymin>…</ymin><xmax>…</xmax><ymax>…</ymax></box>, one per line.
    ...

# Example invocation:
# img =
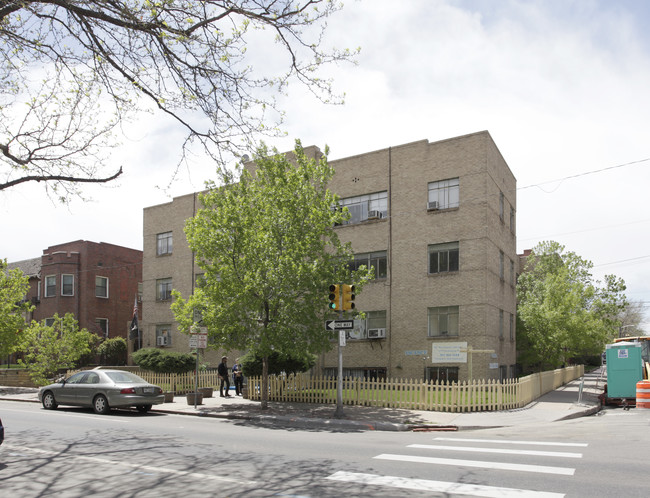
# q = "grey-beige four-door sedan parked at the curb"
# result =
<box><xmin>38</xmin><ymin>369</ymin><xmax>165</xmax><ymax>415</ymax></box>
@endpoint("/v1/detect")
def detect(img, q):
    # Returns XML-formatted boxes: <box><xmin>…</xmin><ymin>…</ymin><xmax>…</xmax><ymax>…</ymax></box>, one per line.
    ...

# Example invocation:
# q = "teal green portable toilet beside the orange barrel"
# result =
<box><xmin>605</xmin><ymin>342</ymin><xmax>643</xmax><ymax>398</ymax></box>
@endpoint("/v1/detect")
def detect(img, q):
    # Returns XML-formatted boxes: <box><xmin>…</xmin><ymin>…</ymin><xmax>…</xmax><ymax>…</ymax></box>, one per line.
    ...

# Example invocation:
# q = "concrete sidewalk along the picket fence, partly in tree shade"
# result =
<box><xmin>0</xmin><ymin>370</ymin><xmax>603</xmax><ymax>431</ymax></box>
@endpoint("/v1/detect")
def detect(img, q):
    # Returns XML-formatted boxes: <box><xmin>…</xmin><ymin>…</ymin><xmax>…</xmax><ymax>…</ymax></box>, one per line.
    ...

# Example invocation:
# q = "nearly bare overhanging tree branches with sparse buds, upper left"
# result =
<box><xmin>0</xmin><ymin>0</ymin><xmax>356</xmax><ymax>201</ymax></box>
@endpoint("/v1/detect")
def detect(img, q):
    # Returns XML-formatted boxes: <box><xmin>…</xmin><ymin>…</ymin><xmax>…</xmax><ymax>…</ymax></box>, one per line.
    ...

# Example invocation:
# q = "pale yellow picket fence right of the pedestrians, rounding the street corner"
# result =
<box><xmin>247</xmin><ymin>365</ymin><xmax>584</xmax><ymax>412</ymax></box>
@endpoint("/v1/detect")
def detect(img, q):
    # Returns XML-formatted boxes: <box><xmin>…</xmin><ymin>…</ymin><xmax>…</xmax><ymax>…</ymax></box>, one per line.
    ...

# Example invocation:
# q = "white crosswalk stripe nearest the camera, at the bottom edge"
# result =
<box><xmin>327</xmin><ymin>472</ymin><xmax>564</xmax><ymax>498</ymax></box>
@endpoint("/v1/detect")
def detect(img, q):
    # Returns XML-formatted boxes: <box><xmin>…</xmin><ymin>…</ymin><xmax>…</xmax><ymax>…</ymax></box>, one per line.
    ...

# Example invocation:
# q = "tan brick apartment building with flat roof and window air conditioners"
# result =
<box><xmin>143</xmin><ymin>132</ymin><xmax>517</xmax><ymax>380</ymax></box>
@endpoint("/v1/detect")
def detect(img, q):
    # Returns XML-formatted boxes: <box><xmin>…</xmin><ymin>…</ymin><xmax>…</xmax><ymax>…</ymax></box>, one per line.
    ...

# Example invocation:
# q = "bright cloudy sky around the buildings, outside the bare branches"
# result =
<box><xmin>0</xmin><ymin>0</ymin><xmax>650</xmax><ymax>333</ymax></box>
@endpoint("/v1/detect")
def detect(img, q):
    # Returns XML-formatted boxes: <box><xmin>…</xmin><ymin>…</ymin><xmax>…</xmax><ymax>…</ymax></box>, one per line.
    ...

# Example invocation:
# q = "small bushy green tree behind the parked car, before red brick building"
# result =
<box><xmin>19</xmin><ymin>313</ymin><xmax>95</xmax><ymax>385</ymax></box>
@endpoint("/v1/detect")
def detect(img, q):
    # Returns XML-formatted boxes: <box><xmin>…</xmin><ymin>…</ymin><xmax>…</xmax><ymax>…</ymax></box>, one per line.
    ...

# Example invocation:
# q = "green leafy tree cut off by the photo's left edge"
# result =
<box><xmin>0</xmin><ymin>259</ymin><xmax>34</xmax><ymax>358</ymax></box>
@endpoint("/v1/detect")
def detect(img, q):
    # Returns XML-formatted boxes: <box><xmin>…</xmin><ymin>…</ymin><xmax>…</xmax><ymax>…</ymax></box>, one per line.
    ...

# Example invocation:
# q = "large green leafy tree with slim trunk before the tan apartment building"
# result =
<box><xmin>172</xmin><ymin>142</ymin><xmax>371</xmax><ymax>408</ymax></box>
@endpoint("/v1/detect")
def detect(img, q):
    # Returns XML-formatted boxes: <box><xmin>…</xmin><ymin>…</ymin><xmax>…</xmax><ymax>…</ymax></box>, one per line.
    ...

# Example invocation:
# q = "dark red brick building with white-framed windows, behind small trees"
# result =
<box><xmin>9</xmin><ymin>240</ymin><xmax>142</xmax><ymax>339</ymax></box>
